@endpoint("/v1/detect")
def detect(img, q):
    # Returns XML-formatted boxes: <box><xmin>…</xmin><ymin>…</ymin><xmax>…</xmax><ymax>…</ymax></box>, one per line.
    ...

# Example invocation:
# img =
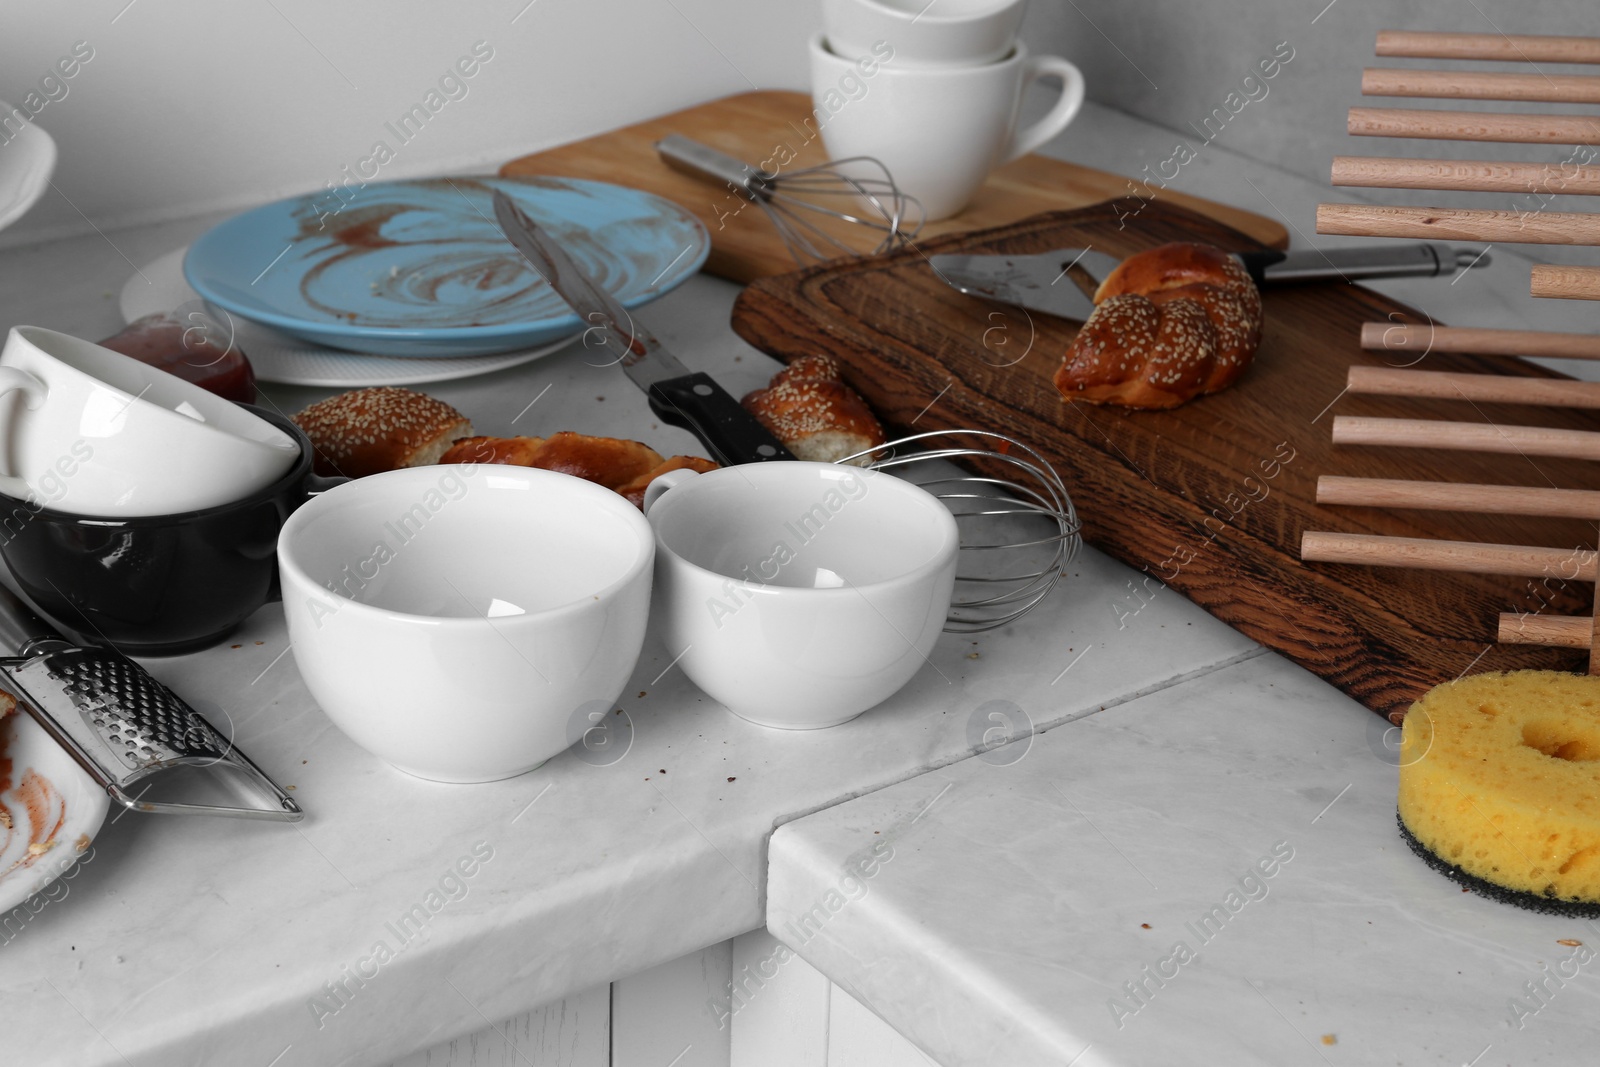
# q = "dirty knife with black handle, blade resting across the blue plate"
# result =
<box><xmin>494</xmin><ymin>190</ymin><xmax>794</xmax><ymax>466</ymax></box>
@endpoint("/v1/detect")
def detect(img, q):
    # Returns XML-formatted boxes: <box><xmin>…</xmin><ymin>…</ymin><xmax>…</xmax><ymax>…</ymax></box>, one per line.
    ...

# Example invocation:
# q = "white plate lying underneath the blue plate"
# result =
<box><xmin>120</xmin><ymin>248</ymin><xmax>578</xmax><ymax>389</ymax></box>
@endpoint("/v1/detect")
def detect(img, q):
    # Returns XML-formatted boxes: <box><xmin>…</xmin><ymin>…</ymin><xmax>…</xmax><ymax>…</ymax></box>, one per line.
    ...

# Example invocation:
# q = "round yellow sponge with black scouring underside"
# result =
<box><xmin>1398</xmin><ymin>670</ymin><xmax>1600</xmax><ymax>917</ymax></box>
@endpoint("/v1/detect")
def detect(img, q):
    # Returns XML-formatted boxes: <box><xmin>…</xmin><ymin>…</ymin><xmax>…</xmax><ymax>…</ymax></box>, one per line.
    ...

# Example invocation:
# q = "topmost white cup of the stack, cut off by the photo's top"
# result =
<box><xmin>822</xmin><ymin>0</ymin><xmax>1027</xmax><ymax>67</ymax></box>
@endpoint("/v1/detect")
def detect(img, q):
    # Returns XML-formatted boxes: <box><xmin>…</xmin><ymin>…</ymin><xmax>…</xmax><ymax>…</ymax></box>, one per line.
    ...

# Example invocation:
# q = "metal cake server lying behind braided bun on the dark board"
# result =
<box><xmin>928</xmin><ymin>245</ymin><xmax>1490</xmax><ymax>320</ymax></box>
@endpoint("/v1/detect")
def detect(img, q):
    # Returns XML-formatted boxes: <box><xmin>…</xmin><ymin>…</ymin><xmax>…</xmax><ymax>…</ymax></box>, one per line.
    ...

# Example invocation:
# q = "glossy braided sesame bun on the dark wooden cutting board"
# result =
<box><xmin>1056</xmin><ymin>242</ymin><xmax>1262</xmax><ymax>408</ymax></box>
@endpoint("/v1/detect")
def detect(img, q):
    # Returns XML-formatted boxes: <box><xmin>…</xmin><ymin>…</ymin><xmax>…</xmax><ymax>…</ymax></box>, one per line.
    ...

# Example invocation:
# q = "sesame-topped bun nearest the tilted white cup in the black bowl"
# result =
<box><xmin>294</xmin><ymin>386</ymin><xmax>472</xmax><ymax>478</ymax></box>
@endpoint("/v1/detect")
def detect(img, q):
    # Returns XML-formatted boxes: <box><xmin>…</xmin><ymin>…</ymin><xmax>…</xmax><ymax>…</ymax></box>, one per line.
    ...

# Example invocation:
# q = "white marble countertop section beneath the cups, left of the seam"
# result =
<box><xmin>0</xmin><ymin>95</ymin><xmax>1574</xmax><ymax>1067</ymax></box>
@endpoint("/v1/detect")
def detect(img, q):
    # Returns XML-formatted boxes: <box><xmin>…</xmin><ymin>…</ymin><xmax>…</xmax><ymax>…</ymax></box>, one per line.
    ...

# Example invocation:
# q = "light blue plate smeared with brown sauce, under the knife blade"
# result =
<box><xmin>184</xmin><ymin>178</ymin><xmax>710</xmax><ymax>358</ymax></box>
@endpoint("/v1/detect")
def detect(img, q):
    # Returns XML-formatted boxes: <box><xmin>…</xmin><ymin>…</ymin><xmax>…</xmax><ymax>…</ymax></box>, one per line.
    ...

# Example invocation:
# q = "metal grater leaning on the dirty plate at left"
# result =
<box><xmin>0</xmin><ymin>587</ymin><xmax>304</xmax><ymax>822</ymax></box>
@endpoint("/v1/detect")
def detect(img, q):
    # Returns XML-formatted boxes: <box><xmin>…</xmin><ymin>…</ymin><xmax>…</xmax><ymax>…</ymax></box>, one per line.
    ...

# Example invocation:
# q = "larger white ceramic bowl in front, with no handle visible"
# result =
<box><xmin>278</xmin><ymin>464</ymin><xmax>654</xmax><ymax>782</ymax></box>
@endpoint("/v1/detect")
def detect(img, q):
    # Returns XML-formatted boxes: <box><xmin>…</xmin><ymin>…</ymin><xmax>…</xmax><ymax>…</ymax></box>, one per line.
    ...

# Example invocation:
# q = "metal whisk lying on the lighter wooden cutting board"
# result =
<box><xmin>656</xmin><ymin>134</ymin><xmax>922</xmax><ymax>267</ymax></box>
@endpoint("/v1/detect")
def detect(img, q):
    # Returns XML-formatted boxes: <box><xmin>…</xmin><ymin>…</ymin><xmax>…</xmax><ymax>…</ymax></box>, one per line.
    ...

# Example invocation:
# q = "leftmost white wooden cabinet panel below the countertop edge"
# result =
<box><xmin>390</xmin><ymin>985</ymin><xmax>611</xmax><ymax>1067</ymax></box>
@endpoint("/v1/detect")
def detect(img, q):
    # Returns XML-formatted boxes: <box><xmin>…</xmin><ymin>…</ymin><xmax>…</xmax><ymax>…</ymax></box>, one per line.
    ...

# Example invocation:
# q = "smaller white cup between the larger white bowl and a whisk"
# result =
<box><xmin>646</xmin><ymin>461</ymin><xmax>960</xmax><ymax>729</ymax></box>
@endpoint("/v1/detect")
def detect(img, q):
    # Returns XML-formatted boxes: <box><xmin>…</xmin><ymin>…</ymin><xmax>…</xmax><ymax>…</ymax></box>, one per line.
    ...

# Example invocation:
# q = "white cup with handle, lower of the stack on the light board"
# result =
<box><xmin>811</xmin><ymin>34</ymin><xmax>1085</xmax><ymax>221</ymax></box>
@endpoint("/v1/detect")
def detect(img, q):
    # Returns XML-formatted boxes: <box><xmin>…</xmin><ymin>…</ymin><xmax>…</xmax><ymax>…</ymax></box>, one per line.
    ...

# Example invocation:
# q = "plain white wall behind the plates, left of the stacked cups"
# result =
<box><xmin>0</xmin><ymin>0</ymin><xmax>819</xmax><ymax>245</ymax></box>
